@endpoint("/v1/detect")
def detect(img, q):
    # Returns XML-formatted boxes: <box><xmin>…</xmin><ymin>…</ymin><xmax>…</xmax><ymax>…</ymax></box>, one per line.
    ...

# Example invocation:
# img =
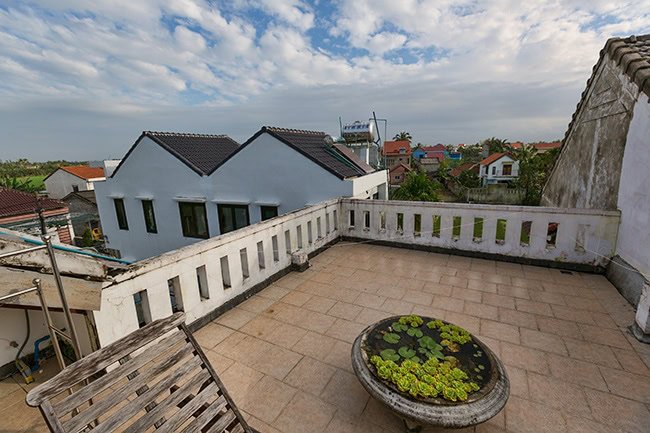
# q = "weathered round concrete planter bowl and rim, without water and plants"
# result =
<box><xmin>352</xmin><ymin>316</ymin><xmax>510</xmax><ymax>431</ymax></box>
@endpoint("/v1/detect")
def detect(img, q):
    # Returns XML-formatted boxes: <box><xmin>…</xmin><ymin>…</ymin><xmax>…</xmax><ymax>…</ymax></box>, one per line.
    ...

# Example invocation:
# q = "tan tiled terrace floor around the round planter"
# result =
<box><xmin>0</xmin><ymin>243</ymin><xmax>650</xmax><ymax>433</ymax></box>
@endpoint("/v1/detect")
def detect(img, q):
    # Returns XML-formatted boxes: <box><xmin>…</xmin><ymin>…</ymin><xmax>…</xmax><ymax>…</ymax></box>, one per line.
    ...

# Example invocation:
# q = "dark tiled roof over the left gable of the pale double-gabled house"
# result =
<box><xmin>111</xmin><ymin>131</ymin><xmax>239</xmax><ymax>177</ymax></box>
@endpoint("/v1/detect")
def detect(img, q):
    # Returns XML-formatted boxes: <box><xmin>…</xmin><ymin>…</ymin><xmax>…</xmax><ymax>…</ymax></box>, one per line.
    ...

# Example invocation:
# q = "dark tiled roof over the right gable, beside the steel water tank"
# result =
<box><xmin>256</xmin><ymin>126</ymin><xmax>367</xmax><ymax>179</ymax></box>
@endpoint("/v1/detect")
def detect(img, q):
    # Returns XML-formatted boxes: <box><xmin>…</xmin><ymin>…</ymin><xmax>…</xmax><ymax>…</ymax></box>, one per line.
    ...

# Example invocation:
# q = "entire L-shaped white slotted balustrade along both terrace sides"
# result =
<box><xmin>93</xmin><ymin>199</ymin><xmax>619</xmax><ymax>346</ymax></box>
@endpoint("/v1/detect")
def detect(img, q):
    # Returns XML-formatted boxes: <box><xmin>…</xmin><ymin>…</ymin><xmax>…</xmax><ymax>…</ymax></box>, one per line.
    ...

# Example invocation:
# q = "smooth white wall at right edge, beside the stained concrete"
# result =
<box><xmin>616</xmin><ymin>93</ymin><xmax>650</xmax><ymax>277</ymax></box>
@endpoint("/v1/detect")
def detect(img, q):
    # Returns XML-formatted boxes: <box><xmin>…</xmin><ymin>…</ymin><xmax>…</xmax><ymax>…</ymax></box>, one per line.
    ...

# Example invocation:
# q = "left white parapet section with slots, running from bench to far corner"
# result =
<box><xmin>93</xmin><ymin>199</ymin><xmax>340</xmax><ymax>347</ymax></box>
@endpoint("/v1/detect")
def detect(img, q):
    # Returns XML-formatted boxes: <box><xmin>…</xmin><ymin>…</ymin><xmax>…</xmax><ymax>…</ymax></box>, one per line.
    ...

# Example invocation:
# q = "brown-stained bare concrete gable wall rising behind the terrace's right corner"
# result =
<box><xmin>541</xmin><ymin>53</ymin><xmax>639</xmax><ymax>210</ymax></box>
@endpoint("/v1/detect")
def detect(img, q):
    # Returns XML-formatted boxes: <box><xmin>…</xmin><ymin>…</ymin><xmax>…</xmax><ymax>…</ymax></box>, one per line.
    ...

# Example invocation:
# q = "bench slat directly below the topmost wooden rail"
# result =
<box><xmin>53</xmin><ymin>331</ymin><xmax>185</xmax><ymax>416</ymax></box>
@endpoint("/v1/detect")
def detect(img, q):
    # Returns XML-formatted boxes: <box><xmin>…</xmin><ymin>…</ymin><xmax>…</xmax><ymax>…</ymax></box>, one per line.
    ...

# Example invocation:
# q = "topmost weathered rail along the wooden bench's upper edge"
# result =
<box><xmin>26</xmin><ymin>313</ymin><xmax>185</xmax><ymax>407</ymax></box>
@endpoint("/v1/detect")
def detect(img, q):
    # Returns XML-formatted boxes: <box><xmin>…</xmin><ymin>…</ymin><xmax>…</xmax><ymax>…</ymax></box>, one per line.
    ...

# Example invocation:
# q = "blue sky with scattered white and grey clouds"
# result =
<box><xmin>0</xmin><ymin>0</ymin><xmax>650</xmax><ymax>160</ymax></box>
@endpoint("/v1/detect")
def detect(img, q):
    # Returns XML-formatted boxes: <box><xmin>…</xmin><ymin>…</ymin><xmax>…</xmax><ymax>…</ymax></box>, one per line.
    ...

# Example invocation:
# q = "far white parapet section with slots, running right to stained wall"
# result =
<box><xmin>341</xmin><ymin>199</ymin><xmax>620</xmax><ymax>267</ymax></box>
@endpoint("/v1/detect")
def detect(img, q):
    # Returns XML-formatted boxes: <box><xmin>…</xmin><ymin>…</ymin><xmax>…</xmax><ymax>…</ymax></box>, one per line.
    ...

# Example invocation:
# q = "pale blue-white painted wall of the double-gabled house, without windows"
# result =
<box><xmin>96</xmin><ymin>134</ymin><xmax>386</xmax><ymax>260</ymax></box>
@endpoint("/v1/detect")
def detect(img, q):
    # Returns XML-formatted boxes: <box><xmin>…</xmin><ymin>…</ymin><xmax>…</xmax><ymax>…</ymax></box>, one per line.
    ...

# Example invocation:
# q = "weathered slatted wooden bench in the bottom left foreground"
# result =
<box><xmin>27</xmin><ymin>313</ymin><xmax>255</xmax><ymax>433</ymax></box>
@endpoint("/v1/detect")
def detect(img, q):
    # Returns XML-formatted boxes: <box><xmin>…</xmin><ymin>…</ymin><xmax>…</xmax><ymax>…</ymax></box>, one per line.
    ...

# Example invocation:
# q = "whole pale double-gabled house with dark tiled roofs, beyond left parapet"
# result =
<box><xmin>96</xmin><ymin>127</ymin><xmax>388</xmax><ymax>260</ymax></box>
